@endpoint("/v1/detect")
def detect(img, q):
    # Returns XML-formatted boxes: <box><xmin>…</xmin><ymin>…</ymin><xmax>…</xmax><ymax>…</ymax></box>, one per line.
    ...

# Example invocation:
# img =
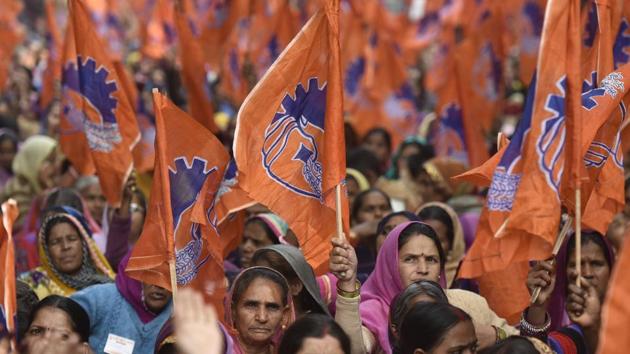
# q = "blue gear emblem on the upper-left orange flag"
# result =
<box><xmin>62</xmin><ymin>56</ymin><xmax>122</xmax><ymax>153</ymax></box>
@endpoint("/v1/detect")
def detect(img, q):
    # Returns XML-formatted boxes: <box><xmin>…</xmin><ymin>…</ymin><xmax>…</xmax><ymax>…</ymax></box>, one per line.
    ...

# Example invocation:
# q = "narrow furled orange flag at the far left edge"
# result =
<box><xmin>0</xmin><ymin>199</ymin><xmax>18</xmax><ymax>345</ymax></box>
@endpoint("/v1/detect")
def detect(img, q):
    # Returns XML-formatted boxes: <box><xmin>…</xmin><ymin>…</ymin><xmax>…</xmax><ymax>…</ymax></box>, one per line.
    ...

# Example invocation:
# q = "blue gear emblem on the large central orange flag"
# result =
<box><xmin>262</xmin><ymin>78</ymin><xmax>326</xmax><ymax>201</ymax></box>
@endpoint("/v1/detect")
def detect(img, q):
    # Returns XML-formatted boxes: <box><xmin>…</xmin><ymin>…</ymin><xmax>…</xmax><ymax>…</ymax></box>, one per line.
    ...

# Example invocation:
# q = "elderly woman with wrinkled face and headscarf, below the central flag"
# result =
<box><xmin>225</xmin><ymin>267</ymin><xmax>294</xmax><ymax>354</ymax></box>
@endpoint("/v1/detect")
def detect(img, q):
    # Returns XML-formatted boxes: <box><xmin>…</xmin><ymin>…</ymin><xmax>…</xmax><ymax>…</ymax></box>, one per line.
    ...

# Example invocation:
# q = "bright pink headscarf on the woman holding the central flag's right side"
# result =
<box><xmin>359</xmin><ymin>221</ymin><xmax>446</xmax><ymax>354</ymax></box>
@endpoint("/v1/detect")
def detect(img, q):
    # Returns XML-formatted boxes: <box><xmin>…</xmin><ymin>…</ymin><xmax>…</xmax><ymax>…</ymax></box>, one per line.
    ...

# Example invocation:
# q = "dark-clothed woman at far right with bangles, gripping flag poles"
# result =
<box><xmin>521</xmin><ymin>231</ymin><xmax>615</xmax><ymax>354</ymax></box>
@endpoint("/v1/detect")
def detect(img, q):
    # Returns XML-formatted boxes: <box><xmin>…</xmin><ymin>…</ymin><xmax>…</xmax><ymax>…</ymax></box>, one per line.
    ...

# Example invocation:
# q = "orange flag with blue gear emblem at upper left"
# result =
<box><xmin>60</xmin><ymin>0</ymin><xmax>140</xmax><ymax>207</ymax></box>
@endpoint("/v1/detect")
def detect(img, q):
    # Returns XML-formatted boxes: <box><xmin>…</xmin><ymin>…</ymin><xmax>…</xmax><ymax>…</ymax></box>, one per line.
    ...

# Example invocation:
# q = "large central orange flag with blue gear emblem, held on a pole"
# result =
<box><xmin>234</xmin><ymin>0</ymin><xmax>348</xmax><ymax>271</ymax></box>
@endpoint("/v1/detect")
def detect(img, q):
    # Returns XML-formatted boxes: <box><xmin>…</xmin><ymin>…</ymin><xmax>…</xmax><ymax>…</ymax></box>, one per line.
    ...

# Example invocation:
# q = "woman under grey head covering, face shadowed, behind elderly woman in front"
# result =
<box><xmin>252</xmin><ymin>245</ymin><xmax>330</xmax><ymax>318</ymax></box>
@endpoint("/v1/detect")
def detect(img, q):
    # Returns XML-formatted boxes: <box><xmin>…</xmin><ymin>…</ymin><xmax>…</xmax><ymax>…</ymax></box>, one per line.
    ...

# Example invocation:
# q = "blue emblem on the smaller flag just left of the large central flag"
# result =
<box><xmin>168</xmin><ymin>157</ymin><xmax>218</xmax><ymax>285</ymax></box>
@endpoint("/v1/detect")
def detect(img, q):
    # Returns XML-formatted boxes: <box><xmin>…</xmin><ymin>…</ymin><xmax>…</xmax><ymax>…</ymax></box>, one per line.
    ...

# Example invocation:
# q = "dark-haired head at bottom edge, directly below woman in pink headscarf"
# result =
<box><xmin>400</xmin><ymin>302</ymin><xmax>478</xmax><ymax>354</ymax></box>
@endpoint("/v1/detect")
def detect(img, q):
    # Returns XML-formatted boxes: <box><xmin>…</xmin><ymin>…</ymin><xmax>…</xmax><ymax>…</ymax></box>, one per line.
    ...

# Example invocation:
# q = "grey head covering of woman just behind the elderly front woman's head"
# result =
<box><xmin>254</xmin><ymin>244</ymin><xmax>330</xmax><ymax>316</ymax></box>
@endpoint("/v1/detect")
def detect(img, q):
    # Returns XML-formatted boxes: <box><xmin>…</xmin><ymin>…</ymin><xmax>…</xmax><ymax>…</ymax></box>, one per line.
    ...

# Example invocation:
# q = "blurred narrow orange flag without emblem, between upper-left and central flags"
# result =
<box><xmin>175</xmin><ymin>4</ymin><xmax>219</xmax><ymax>134</ymax></box>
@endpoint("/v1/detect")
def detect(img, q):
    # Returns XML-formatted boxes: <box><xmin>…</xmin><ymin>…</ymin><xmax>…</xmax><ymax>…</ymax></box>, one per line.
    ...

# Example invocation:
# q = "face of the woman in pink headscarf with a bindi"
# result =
<box><xmin>398</xmin><ymin>234</ymin><xmax>440</xmax><ymax>288</ymax></box>
